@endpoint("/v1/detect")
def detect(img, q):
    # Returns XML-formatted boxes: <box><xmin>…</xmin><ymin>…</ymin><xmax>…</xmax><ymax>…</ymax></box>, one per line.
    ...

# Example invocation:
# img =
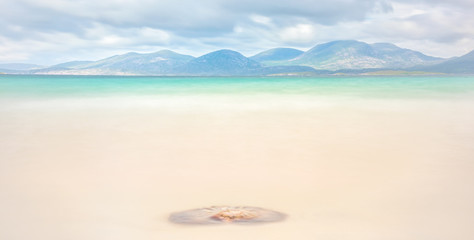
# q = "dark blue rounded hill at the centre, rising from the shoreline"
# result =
<box><xmin>178</xmin><ymin>50</ymin><xmax>262</xmax><ymax>75</ymax></box>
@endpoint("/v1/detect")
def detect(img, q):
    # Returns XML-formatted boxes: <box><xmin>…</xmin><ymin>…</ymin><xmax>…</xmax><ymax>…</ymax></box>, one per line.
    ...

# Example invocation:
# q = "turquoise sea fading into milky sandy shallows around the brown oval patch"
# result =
<box><xmin>0</xmin><ymin>76</ymin><xmax>474</xmax><ymax>240</ymax></box>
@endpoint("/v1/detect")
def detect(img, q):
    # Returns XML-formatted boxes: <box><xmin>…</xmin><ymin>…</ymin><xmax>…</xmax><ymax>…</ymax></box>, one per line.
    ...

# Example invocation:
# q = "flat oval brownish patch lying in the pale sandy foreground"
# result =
<box><xmin>169</xmin><ymin>206</ymin><xmax>286</xmax><ymax>224</ymax></box>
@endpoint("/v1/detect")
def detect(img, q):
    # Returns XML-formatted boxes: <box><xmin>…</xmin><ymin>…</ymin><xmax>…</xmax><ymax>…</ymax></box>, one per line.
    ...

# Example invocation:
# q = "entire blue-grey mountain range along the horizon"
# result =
<box><xmin>0</xmin><ymin>40</ymin><xmax>474</xmax><ymax>76</ymax></box>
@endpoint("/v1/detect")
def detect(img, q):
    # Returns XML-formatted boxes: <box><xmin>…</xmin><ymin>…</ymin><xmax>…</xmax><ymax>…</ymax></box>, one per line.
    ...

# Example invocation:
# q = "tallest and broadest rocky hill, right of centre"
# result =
<box><xmin>281</xmin><ymin>40</ymin><xmax>443</xmax><ymax>70</ymax></box>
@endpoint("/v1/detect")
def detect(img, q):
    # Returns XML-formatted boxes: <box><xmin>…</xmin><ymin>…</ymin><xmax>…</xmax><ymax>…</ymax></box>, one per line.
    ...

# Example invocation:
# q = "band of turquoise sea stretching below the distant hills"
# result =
<box><xmin>0</xmin><ymin>75</ymin><xmax>474</xmax><ymax>98</ymax></box>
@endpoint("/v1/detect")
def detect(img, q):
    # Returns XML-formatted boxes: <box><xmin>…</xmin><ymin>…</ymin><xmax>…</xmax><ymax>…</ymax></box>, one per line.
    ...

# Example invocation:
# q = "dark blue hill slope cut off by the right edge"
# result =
<box><xmin>413</xmin><ymin>51</ymin><xmax>474</xmax><ymax>74</ymax></box>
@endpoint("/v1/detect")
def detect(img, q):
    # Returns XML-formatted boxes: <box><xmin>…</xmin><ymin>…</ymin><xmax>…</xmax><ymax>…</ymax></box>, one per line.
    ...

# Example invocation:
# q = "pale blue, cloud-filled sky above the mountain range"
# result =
<box><xmin>0</xmin><ymin>0</ymin><xmax>474</xmax><ymax>65</ymax></box>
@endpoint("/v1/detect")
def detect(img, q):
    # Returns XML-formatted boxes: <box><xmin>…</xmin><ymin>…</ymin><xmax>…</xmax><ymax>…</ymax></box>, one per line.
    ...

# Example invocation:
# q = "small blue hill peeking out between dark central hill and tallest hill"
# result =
<box><xmin>250</xmin><ymin>48</ymin><xmax>304</xmax><ymax>66</ymax></box>
